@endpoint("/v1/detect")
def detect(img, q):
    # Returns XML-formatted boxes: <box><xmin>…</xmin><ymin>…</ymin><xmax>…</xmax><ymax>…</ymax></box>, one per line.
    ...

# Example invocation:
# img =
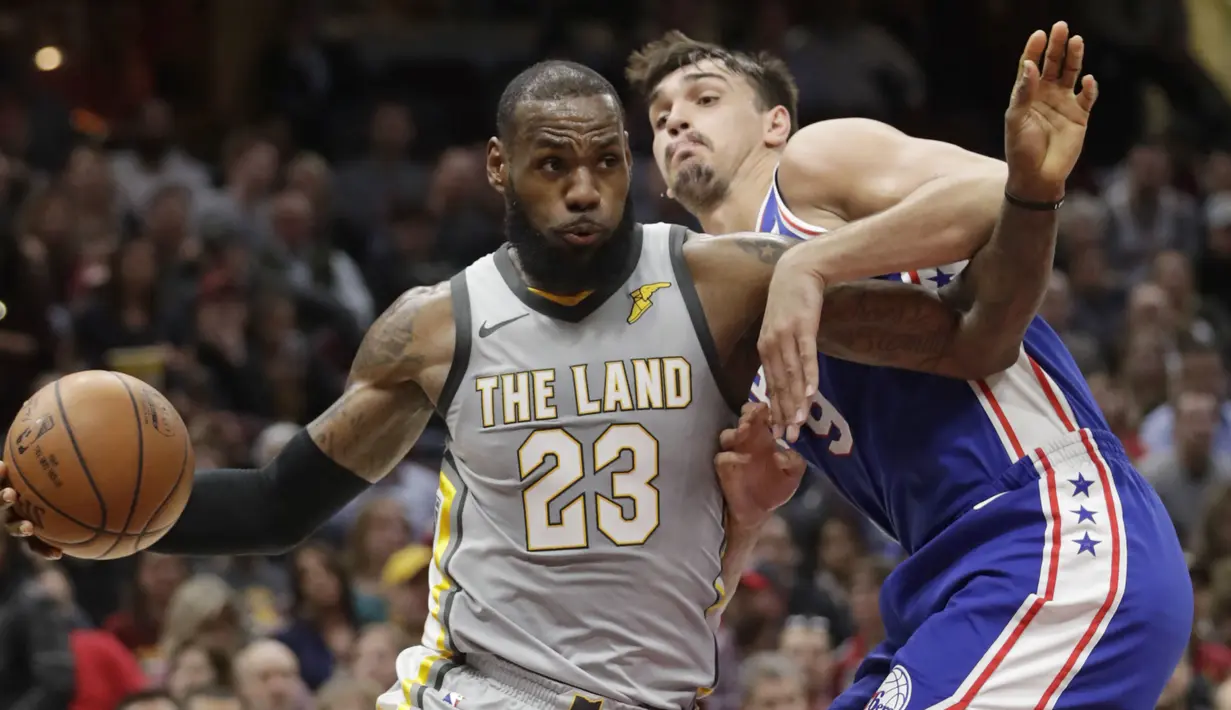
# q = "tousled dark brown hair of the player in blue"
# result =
<box><xmin>624</xmin><ymin>30</ymin><xmax>799</xmax><ymax>133</ymax></box>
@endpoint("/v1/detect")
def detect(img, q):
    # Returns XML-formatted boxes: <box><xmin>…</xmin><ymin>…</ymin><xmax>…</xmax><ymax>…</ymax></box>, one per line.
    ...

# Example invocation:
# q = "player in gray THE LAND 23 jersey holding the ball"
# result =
<box><xmin>0</xmin><ymin>38</ymin><xmax>1092</xmax><ymax>710</ymax></box>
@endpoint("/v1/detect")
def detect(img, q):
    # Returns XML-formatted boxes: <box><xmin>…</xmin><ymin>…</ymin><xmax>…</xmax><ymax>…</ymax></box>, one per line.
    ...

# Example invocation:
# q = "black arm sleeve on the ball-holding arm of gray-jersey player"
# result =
<box><xmin>151</xmin><ymin>429</ymin><xmax>372</xmax><ymax>555</ymax></box>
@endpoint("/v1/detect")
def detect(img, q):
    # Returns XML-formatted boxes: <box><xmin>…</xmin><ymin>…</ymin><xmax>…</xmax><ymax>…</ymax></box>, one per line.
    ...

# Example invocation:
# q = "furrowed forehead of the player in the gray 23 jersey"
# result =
<box><xmin>517</xmin><ymin>96</ymin><xmax>624</xmax><ymax>146</ymax></box>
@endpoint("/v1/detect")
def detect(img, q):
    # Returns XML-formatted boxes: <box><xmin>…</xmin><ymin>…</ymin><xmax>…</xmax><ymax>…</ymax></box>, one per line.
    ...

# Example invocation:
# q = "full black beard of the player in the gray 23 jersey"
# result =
<box><xmin>505</xmin><ymin>186</ymin><xmax>636</xmax><ymax>295</ymax></box>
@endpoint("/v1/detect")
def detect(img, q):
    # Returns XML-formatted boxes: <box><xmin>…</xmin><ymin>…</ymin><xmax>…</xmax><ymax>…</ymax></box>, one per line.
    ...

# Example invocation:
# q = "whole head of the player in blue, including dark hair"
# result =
<box><xmin>625</xmin><ymin>32</ymin><xmax>799</xmax><ymax>212</ymax></box>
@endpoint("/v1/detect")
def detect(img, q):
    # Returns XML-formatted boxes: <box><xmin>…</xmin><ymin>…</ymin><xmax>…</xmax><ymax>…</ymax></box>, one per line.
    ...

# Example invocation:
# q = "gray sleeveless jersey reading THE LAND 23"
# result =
<box><xmin>410</xmin><ymin>224</ymin><xmax>735</xmax><ymax>708</ymax></box>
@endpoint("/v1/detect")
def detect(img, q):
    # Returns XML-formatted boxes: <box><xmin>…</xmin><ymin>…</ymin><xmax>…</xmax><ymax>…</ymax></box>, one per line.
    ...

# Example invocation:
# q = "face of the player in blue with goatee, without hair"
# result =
<box><xmin>649</xmin><ymin>60</ymin><xmax>766</xmax><ymax>205</ymax></box>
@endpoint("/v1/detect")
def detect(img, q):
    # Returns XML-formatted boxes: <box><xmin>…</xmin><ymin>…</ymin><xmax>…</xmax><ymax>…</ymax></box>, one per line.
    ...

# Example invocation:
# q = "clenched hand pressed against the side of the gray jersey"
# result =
<box><xmin>714</xmin><ymin>402</ymin><xmax>806</xmax><ymax>529</ymax></box>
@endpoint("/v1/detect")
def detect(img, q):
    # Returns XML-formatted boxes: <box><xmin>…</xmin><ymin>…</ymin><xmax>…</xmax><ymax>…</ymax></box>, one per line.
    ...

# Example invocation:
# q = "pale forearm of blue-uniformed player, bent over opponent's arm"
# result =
<box><xmin>800</xmin><ymin>166</ymin><xmax>1004</xmax><ymax>284</ymax></box>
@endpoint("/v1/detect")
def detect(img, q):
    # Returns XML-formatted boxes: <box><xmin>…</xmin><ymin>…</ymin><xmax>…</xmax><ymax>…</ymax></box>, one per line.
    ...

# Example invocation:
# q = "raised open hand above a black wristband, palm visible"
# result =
<box><xmin>1004</xmin><ymin>22</ymin><xmax>1098</xmax><ymax>202</ymax></box>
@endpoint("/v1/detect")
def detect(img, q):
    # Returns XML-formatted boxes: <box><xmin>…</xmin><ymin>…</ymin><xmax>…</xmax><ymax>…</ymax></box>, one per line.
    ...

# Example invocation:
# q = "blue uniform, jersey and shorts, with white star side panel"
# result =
<box><xmin>753</xmin><ymin>173</ymin><xmax>1193</xmax><ymax>710</ymax></box>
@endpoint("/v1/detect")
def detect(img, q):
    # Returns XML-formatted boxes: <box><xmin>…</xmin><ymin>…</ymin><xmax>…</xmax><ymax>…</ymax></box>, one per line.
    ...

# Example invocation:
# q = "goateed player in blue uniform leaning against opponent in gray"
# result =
<box><xmin>630</xmin><ymin>23</ymin><xmax>1193</xmax><ymax>710</ymax></box>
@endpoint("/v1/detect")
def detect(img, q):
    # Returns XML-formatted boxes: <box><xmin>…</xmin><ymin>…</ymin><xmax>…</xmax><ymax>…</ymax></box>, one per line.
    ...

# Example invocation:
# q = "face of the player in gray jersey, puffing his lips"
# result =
<box><xmin>487</xmin><ymin>96</ymin><xmax>632</xmax><ymax>255</ymax></box>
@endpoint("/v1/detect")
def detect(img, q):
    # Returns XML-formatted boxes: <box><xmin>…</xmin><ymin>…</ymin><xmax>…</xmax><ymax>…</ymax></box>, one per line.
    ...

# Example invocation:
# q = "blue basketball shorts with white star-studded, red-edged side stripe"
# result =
<box><xmin>832</xmin><ymin>429</ymin><xmax>1193</xmax><ymax>710</ymax></box>
